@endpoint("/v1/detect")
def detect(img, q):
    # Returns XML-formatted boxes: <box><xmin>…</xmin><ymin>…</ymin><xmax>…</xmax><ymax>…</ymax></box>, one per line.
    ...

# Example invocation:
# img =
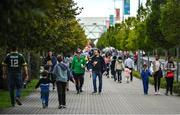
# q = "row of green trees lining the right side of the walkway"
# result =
<box><xmin>97</xmin><ymin>0</ymin><xmax>180</xmax><ymax>51</ymax></box>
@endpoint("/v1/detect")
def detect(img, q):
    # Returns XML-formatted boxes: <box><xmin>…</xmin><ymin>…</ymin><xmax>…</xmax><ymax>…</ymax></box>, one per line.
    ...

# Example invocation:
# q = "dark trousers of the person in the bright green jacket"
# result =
<box><xmin>74</xmin><ymin>73</ymin><xmax>84</xmax><ymax>92</ymax></box>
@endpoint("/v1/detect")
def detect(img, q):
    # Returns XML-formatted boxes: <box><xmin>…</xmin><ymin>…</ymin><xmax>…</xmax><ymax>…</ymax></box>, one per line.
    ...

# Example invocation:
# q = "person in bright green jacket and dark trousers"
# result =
<box><xmin>71</xmin><ymin>51</ymin><xmax>86</xmax><ymax>94</ymax></box>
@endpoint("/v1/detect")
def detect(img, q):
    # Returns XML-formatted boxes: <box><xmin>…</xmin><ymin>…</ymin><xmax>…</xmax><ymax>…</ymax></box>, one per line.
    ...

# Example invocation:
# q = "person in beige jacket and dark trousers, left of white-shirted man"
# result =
<box><xmin>115</xmin><ymin>57</ymin><xmax>124</xmax><ymax>83</ymax></box>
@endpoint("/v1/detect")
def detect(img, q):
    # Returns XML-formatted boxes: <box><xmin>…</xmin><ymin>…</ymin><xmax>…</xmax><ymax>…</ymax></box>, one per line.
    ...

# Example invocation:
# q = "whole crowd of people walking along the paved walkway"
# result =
<box><xmin>3</xmin><ymin>47</ymin><xmax>176</xmax><ymax>109</ymax></box>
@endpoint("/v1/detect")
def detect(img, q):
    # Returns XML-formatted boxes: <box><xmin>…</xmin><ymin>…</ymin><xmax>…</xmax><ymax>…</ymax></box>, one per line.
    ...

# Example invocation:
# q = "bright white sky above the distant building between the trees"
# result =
<box><xmin>74</xmin><ymin>0</ymin><xmax>145</xmax><ymax>17</ymax></box>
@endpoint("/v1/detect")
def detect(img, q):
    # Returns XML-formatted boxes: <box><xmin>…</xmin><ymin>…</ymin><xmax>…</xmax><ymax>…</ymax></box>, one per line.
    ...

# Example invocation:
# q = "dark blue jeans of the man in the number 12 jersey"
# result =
<box><xmin>8</xmin><ymin>73</ymin><xmax>23</xmax><ymax>105</ymax></box>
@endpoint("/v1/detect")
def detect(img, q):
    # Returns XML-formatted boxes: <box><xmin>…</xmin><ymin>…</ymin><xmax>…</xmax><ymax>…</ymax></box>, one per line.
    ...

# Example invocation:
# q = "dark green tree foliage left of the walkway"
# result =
<box><xmin>0</xmin><ymin>0</ymin><xmax>86</xmax><ymax>52</ymax></box>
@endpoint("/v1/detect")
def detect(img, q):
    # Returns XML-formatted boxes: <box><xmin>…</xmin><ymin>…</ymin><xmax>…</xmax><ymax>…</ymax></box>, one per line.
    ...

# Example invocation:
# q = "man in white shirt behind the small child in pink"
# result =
<box><xmin>124</xmin><ymin>55</ymin><xmax>134</xmax><ymax>81</ymax></box>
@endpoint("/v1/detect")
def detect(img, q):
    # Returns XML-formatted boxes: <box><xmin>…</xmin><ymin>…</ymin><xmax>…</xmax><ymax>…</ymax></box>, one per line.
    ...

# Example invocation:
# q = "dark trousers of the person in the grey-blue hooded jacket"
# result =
<box><xmin>56</xmin><ymin>81</ymin><xmax>66</xmax><ymax>105</ymax></box>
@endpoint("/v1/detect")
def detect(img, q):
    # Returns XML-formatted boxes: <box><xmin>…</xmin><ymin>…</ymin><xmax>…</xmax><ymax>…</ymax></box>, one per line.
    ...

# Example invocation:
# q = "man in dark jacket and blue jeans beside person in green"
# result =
<box><xmin>91</xmin><ymin>49</ymin><xmax>106</xmax><ymax>94</ymax></box>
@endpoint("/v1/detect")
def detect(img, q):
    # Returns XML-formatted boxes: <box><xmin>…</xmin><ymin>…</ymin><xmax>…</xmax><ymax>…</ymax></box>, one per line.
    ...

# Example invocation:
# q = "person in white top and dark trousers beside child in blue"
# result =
<box><xmin>152</xmin><ymin>55</ymin><xmax>163</xmax><ymax>95</ymax></box>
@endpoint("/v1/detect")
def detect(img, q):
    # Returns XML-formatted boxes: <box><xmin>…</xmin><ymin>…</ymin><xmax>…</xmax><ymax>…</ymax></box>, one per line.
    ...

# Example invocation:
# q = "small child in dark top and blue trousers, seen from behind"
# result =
<box><xmin>35</xmin><ymin>70</ymin><xmax>52</xmax><ymax>108</ymax></box>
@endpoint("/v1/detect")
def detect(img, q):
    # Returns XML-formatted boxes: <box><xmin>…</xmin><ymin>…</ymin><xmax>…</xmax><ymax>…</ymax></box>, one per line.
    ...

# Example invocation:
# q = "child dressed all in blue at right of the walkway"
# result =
<box><xmin>141</xmin><ymin>64</ymin><xmax>151</xmax><ymax>95</ymax></box>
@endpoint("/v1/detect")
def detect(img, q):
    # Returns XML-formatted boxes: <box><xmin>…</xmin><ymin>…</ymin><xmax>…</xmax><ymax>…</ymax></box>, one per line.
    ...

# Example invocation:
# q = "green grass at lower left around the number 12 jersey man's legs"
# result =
<box><xmin>0</xmin><ymin>79</ymin><xmax>38</xmax><ymax>109</ymax></box>
